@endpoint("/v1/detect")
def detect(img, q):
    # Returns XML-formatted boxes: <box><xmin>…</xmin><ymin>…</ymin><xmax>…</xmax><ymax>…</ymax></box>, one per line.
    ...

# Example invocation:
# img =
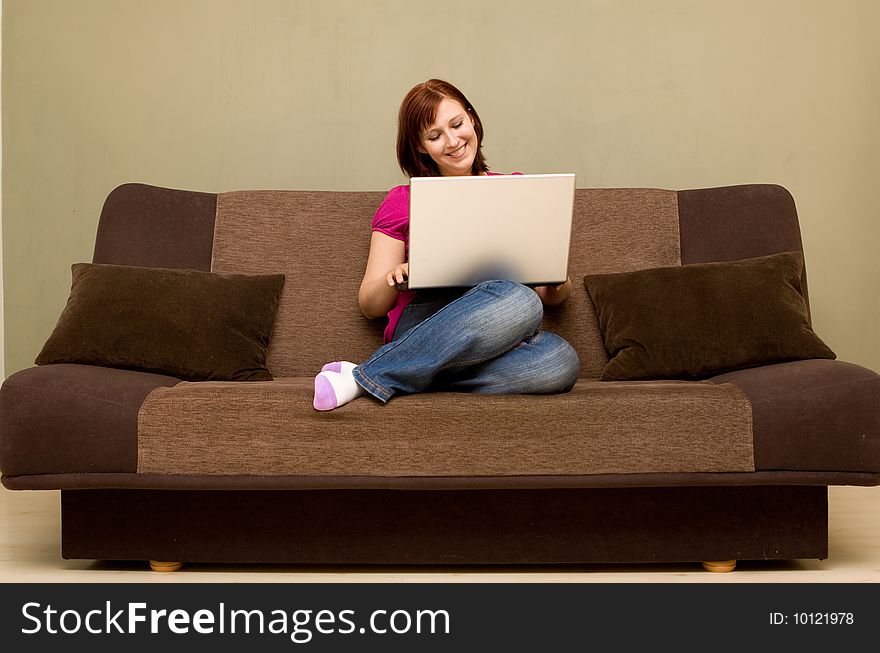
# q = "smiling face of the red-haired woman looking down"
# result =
<box><xmin>419</xmin><ymin>98</ymin><xmax>477</xmax><ymax>177</ymax></box>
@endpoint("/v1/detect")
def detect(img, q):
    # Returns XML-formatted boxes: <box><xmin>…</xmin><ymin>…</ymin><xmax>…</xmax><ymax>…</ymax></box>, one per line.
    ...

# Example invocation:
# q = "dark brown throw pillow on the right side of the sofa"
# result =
<box><xmin>584</xmin><ymin>252</ymin><xmax>835</xmax><ymax>381</ymax></box>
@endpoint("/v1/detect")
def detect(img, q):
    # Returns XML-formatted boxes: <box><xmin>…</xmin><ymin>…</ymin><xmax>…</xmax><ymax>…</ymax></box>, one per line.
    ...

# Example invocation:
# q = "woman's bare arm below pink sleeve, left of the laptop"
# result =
<box><xmin>358</xmin><ymin>231</ymin><xmax>408</xmax><ymax>320</ymax></box>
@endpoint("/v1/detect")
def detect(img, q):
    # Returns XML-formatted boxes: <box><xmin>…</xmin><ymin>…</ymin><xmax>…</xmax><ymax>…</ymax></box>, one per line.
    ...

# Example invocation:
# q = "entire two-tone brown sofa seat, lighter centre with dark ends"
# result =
<box><xmin>0</xmin><ymin>360</ymin><xmax>880</xmax><ymax>487</ymax></box>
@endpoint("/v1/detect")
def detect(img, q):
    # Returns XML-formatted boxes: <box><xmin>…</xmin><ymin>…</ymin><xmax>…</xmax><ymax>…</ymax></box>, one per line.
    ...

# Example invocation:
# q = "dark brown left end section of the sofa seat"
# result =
<box><xmin>0</xmin><ymin>364</ymin><xmax>180</xmax><ymax>476</ymax></box>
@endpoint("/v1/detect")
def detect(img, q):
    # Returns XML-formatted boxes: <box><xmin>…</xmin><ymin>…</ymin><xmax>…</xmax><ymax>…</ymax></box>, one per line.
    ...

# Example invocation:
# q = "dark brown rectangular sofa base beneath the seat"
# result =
<box><xmin>61</xmin><ymin>486</ymin><xmax>828</xmax><ymax>565</ymax></box>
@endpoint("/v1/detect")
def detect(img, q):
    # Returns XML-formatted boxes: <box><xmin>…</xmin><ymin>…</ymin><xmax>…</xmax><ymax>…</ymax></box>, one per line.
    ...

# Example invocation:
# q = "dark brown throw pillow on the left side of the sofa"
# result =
<box><xmin>35</xmin><ymin>263</ymin><xmax>284</xmax><ymax>381</ymax></box>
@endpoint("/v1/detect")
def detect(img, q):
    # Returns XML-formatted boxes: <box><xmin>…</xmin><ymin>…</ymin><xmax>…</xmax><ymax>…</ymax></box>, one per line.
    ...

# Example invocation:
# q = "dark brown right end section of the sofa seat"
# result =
<box><xmin>711</xmin><ymin>359</ymin><xmax>880</xmax><ymax>472</ymax></box>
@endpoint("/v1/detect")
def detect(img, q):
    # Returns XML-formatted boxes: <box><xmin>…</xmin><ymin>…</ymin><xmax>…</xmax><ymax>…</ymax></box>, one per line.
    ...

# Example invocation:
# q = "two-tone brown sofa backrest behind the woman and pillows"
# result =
<box><xmin>93</xmin><ymin>184</ymin><xmax>806</xmax><ymax>378</ymax></box>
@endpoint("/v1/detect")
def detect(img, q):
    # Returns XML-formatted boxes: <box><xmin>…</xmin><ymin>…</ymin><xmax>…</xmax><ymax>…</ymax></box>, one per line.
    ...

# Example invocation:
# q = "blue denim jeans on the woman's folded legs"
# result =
<box><xmin>354</xmin><ymin>281</ymin><xmax>580</xmax><ymax>402</ymax></box>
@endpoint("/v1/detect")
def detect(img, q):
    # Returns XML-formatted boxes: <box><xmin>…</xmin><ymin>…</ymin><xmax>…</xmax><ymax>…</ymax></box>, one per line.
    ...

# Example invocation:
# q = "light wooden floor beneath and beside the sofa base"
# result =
<box><xmin>0</xmin><ymin>487</ymin><xmax>880</xmax><ymax>583</ymax></box>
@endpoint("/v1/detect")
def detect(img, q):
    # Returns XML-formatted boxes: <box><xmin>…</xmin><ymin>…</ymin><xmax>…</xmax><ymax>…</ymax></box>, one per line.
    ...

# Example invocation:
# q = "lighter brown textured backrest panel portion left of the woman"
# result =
<box><xmin>211</xmin><ymin>191</ymin><xmax>385</xmax><ymax>376</ymax></box>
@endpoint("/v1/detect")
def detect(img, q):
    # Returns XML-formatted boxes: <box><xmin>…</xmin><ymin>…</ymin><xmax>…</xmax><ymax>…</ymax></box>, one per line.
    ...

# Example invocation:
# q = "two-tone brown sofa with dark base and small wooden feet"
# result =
<box><xmin>0</xmin><ymin>183</ymin><xmax>880</xmax><ymax>571</ymax></box>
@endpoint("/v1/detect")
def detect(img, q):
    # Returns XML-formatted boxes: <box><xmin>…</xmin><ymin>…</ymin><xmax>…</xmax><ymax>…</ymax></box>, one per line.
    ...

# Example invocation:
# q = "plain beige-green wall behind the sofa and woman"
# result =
<box><xmin>2</xmin><ymin>0</ymin><xmax>880</xmax><ymax>373</ymax></box>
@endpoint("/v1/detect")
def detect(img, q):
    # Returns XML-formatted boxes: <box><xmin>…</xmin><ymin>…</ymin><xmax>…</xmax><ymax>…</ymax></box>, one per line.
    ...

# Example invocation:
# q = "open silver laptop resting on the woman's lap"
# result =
<box><xmin>408</xmin><ymin>173</ymin><xmax>575</xmax><ymax>290</ymax></box>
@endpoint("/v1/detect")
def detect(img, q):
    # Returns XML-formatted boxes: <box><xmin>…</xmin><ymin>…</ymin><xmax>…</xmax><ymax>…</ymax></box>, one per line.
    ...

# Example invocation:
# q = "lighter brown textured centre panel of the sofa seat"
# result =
<box><xmin>138</xmin><ymin>377</ymin><xmax>754</xmax><ymax>477</ymax></box>
